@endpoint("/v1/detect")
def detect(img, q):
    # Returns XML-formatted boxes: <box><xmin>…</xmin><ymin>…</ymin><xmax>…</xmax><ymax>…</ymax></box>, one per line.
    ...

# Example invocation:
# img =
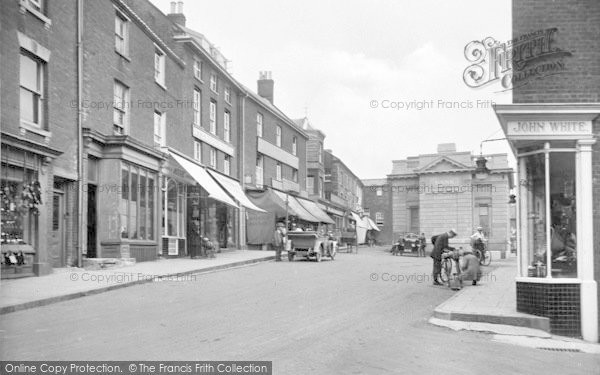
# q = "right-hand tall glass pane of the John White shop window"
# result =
<box><xmin>550</xmin><ymin>152</ymin><xmax>577</xmax><ymax>278</ymax></box>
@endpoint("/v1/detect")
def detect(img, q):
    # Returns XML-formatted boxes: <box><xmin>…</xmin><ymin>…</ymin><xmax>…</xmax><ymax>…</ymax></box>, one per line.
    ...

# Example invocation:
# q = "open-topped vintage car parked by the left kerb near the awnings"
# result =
<box><xmin>287</xmin><ymin>231</ymin><xmax>336</xmax><ymax>262</ymax></box>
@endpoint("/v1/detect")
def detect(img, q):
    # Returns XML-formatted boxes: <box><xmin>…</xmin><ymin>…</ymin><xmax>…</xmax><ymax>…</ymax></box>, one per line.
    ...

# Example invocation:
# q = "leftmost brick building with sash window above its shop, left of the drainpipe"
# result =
<box><xmin>0</xmin><ymin>1</ymin><xmax>79</xmax><ymax>277</ymax></box>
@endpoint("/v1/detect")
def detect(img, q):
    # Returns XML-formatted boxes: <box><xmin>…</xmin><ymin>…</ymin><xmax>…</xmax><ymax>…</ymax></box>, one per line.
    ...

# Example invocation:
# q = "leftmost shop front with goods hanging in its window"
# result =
<box><xmin>0</xmin><ymin>133</ymin><xmax>65</xmax><ymax>279</ymax></box>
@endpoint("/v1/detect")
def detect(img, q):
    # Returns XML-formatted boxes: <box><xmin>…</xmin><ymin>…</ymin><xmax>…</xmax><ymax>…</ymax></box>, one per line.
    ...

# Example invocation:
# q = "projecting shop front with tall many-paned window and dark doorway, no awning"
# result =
<box><xmin>83</xmin><ymin>129</ymin><xmax>165</xmax><ymax>262</ymax></box>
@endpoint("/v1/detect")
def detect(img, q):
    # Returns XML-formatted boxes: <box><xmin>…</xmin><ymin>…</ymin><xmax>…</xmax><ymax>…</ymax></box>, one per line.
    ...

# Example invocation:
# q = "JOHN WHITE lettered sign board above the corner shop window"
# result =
<box><xmin>506</xmin><ymin>120</ymin><xmax>592</xmax><ymax>138</ymax></box>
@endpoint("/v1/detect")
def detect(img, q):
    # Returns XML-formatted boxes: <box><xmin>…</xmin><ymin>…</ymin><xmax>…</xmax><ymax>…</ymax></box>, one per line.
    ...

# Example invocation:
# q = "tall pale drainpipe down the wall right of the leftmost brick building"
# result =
<box><xmin>77</xmin><ymin>0</ymin><xmax>84</xmax><ymax>268</ymax></box>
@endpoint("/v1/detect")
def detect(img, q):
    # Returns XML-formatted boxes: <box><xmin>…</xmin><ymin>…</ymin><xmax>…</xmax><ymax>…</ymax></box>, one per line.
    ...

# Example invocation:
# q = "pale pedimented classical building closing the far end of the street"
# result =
<box><xmin>363</xmin><ymin>143</ymin><xmax>513</xmax><ymax>256</ymax></box>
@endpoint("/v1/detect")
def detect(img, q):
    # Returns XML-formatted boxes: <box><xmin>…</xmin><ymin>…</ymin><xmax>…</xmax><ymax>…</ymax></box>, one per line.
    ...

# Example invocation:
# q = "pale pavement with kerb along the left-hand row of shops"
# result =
<box><xmin>0</xmin><ymin>250</ymin><xmax>275</xmax><ymax>314</ymax></box>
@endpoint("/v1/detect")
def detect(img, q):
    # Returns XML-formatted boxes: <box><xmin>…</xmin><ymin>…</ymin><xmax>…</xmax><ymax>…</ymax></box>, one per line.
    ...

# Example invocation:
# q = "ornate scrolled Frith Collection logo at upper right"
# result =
<box><xmin>463</xmin><ymin>28</ymin><xmax>572</xmax><ymax>91</ymax></box>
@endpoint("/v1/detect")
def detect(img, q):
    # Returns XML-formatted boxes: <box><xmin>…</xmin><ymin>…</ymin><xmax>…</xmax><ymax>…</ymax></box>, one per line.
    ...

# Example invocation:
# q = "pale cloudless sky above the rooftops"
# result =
<box><xmin>151</xmin><ymin>0</ymin><xmax>514</xmax><ymax>179</ymax></box>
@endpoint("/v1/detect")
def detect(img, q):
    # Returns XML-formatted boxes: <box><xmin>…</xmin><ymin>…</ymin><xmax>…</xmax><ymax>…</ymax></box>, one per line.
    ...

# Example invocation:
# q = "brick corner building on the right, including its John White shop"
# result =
<box><xmin>492</xmin><ymin>0</ymin><xmax>600</xmax><ymax>342</ymax></box>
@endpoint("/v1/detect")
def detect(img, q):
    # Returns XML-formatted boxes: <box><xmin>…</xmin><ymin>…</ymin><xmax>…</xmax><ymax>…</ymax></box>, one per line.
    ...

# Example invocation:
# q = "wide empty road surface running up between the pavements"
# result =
<box><xmin>0</xmin><ymin>248</ymin><xmax>600</xmax><ymax>375</ymax></box>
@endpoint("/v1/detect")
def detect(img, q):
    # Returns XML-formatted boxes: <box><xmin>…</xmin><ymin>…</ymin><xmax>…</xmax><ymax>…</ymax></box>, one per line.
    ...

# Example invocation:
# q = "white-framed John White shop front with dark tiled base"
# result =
<box><xmin>495</xmin><ymin>104</ymin><xmax>600</xmax><ymax>342</ymax></box>
